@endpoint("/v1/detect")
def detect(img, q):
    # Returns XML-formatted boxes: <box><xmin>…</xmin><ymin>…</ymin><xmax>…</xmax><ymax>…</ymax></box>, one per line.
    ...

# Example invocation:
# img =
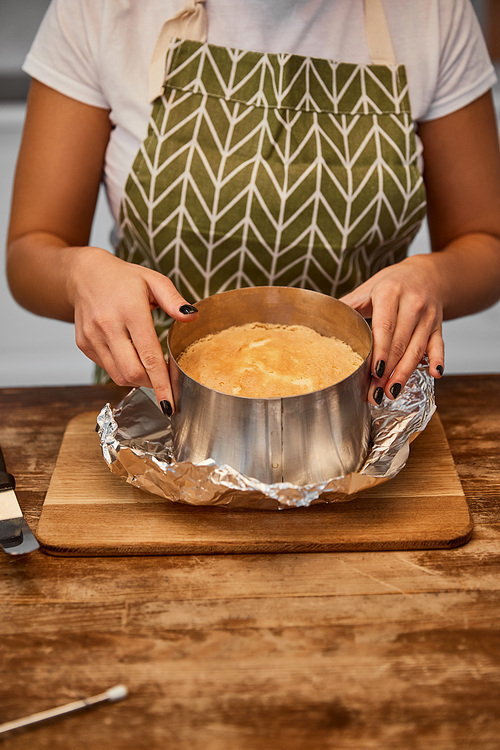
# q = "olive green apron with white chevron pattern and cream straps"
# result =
<box><xmin>94</xmin><ymin>0</ymin><xmax>425</xmax><ymax>378</ymax></box>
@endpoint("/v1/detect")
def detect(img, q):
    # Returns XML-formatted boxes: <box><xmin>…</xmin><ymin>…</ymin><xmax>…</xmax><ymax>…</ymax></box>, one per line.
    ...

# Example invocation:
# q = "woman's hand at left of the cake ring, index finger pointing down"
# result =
<box><xmin>67</xmin><ymin>247</ymin><xmax>198</xmax><ymax>414</ymax></box>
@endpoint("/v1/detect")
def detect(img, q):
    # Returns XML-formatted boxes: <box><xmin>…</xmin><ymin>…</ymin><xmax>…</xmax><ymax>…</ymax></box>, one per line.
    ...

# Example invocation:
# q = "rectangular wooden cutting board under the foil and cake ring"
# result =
<box><xmin>37</xmin><ymin>412</ymin><xmax>472</xmax><ymax>556</ymax></box>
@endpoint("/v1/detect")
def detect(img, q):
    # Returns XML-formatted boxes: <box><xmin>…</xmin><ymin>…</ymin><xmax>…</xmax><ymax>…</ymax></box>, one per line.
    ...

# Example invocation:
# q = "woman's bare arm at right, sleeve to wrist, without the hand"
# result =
<box><xmin>419</xmin><ymin>93</ymin><xmax>500</xmax><ymax>319</ymax></box>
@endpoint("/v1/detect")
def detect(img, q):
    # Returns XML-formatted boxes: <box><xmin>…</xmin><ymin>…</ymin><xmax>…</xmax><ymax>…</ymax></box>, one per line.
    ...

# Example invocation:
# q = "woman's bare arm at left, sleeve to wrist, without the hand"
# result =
<box><xmin>7</xmin><ymin>81</ymin><xmax>110</xmax><ymax>321</ymax></box>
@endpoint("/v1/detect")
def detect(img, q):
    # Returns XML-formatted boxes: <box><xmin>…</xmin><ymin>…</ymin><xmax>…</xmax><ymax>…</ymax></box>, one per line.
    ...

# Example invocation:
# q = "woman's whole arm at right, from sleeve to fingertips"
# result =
<box><xmin>343</xmin><ymin>93</ymin><xmax>500</xmax><ymax>402</ymax></box>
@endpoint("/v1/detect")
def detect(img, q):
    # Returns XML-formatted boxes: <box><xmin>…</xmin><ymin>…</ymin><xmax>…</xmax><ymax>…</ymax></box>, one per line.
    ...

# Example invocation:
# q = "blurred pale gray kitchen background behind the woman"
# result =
<box><xmin>0</xmin><ymin>0</ymin><xmax>500</xmax><ymax>387</ymax></box>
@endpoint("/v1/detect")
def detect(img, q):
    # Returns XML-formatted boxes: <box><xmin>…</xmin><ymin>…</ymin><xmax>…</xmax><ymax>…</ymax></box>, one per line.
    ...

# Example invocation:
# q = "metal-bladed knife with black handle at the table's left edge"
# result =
<box><xmin>0</xmin><ymin>448</ymin><xmax>40</xmax><ymax>555</ymax></box>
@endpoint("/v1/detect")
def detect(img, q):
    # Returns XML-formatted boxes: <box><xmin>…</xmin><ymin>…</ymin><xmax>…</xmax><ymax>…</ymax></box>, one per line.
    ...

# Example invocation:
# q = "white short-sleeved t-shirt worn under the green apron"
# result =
<box><xmin>23</xmin><ymin>0</ymin><xmax>496</xmax><ymax>225</ymax></box>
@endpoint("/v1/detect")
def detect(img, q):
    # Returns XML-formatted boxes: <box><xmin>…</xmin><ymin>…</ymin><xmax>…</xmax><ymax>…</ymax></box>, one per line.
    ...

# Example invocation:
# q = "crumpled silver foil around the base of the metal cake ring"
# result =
<box><xmin>97</xmin><ymin>365</ymin><xmax>436</xmax><ymax>510</ymax></box>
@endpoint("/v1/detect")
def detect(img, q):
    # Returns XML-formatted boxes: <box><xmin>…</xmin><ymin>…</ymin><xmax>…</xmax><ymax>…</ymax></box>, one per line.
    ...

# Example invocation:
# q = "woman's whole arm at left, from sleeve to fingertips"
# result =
<box><xmin>7</xmin><ymin>81</ymin><xmax>194</xmax><ymax>412</ymax></box>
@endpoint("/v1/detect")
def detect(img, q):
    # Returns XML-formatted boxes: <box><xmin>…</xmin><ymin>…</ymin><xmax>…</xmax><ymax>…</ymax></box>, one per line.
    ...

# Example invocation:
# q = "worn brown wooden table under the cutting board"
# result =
<box><xmin>0</xmin><ymin>375</ymin><xmax>500</xmax><ymax>750</ymax></box>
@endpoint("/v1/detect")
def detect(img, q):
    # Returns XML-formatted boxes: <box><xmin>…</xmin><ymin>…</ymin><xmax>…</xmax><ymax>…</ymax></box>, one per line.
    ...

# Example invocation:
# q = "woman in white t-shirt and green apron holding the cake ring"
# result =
<box><xmin>7</xmin><ymin>0</ymin><xmax>500</xmax><ymax>413</ymax></box>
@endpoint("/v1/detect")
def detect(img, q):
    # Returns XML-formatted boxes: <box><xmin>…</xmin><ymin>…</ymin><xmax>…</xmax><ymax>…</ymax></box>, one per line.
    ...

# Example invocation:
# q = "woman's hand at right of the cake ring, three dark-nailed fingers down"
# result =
<box><xmin>341</xmin><ymin>255</ymin><xmax>444</xmax><ymax>404</ymax></box>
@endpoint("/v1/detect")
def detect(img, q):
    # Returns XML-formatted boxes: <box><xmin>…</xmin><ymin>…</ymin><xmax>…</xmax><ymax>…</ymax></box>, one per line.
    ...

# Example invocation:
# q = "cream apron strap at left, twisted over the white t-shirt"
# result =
<box><xmin>149</xmin><ymin>0</ymin><xmax>208</xmax><ymax>102</ymax></box>
